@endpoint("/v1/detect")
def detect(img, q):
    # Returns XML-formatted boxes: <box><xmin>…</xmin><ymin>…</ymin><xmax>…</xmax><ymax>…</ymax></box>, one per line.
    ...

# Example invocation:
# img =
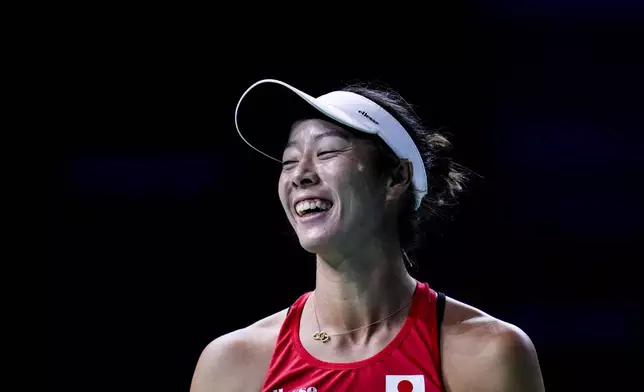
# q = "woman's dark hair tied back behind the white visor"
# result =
<box><xmin>342</xmin><ymin>84</ymin><xmax>469</xmax><ymax>266</ymax></box>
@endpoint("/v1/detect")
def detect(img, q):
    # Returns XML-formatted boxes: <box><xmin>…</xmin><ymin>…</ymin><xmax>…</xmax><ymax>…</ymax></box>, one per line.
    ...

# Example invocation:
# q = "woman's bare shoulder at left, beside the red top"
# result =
<box><xmin>190</xmin><ymin>309</ymin><xmax>287</xmax><ymax>392</ymax></box>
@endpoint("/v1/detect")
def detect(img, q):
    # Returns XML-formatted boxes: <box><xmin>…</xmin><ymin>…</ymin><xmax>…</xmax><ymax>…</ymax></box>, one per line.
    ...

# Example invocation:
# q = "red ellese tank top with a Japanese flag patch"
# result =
<box><xmin>262</xmin><ymin>282</ymin><xmax>443</xmax><ymax>392</ymax></box>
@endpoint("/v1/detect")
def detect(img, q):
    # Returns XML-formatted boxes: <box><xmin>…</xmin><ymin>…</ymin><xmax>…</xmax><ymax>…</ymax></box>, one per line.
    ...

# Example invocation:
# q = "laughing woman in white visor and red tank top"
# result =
<box><xmin>191</xmin><ymin>80</ymin><xmax>544</xmax><ymax>392</ymax></box>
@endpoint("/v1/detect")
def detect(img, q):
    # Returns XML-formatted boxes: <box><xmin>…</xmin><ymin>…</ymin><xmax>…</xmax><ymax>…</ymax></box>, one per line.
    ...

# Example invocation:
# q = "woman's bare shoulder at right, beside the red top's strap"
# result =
<box><xmin>441</xmin><ymin>298</ymin><xmax>544</xmax><ymax>392</ymax></box>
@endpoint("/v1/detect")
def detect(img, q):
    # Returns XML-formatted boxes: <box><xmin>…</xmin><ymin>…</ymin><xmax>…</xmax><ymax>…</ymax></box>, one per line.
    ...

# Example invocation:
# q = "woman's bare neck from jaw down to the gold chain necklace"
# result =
<box><xmin>314</xmin><ymin>237</ymin><xmax>416</xmax><ymax>334</ymax></box>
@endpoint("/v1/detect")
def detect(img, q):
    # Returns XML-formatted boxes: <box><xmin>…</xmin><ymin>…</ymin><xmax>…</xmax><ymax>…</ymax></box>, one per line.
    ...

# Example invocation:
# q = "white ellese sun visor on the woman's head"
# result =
<box><xmin>235</xmin><ymin>79</ymin><xmax>427</xmax><ymax>209</ymax></box>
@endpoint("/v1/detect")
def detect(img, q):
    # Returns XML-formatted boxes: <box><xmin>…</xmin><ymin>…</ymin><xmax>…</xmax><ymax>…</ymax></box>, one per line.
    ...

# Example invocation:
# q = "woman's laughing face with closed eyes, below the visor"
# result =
<box><xmin>279</xmin><ymin>119</ymin><xmax>387</xmax><ymax>254</ymax></box>
